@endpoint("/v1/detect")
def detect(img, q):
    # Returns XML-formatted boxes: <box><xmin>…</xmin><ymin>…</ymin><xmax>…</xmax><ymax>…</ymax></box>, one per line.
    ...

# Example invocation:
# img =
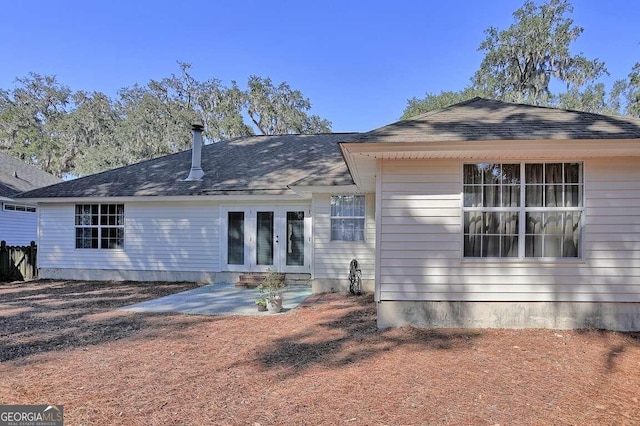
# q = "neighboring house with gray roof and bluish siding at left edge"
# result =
<box><xmin>0</xmin><ymin>152</ymin><xmax>60</xmax><ymax>246</ymax></box>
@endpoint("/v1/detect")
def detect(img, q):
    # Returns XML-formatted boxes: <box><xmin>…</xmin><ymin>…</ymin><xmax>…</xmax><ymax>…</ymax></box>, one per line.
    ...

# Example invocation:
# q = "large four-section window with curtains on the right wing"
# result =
<box><xmin>463</xmin><ymin>162</ymin><xmax>584</xmax><ymax>258</ymax></box>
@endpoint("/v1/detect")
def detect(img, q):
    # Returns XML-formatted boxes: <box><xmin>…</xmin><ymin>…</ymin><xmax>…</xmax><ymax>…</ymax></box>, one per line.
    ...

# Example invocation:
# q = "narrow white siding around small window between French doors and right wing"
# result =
<box><xmin>312</xmin><ymin>194</ymin><xmax>376</xmax><ymax>280</ymax></box>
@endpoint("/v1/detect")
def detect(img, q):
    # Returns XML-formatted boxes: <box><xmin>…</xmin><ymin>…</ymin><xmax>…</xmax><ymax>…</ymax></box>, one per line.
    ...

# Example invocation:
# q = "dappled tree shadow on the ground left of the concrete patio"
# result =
<box><xmin>0</xmin><ymin>280</ymin><xmax>211</xmax><ymax>362</ymax></box>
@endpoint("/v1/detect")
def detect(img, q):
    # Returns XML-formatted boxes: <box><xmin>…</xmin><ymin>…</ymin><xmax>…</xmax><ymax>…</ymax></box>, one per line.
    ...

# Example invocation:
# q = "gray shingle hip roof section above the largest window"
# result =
<box><xmin>352</xmin><ymin>98</ymin><xmax>640</xmax><ymax>143</ymax></box>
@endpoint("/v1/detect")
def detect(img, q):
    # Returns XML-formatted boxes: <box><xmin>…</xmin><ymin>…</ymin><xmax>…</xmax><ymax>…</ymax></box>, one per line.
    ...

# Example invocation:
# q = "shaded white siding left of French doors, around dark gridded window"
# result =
<box><xmin>38</xmin><ymin>203</ymin><xmax>220</xmax><ymax>272</ymax></box>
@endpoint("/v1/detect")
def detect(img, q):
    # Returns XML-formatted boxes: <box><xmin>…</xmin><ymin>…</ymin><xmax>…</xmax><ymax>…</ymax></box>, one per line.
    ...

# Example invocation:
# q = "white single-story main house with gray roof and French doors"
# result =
<box><xmin>16</xmin><ymin>98</ymin><xmax>640</xmax><ymax>330</ymax></box>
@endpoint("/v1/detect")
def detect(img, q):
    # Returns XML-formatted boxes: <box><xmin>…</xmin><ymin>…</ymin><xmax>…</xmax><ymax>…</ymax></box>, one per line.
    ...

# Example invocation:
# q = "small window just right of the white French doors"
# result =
<box><xmin>331</xmin><ymin>195</ymin><xmax>365</xmax><ymax>241</ymax></box>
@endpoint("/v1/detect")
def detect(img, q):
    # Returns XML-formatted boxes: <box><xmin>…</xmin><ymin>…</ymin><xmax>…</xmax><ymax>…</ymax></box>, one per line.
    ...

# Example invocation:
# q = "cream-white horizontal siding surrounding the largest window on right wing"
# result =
<box><xmin>378</xmin><ymin>158</ymin><xmax>640</xmax><ymax>302</ymax></box>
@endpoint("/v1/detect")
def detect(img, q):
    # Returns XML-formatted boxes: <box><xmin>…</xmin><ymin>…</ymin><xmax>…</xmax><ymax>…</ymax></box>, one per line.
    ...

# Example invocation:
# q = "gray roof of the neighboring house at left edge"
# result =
<box><xmin>0</xmin><ymin>152</ymin><xmax>60</xmax><ymax>198</ymax></box>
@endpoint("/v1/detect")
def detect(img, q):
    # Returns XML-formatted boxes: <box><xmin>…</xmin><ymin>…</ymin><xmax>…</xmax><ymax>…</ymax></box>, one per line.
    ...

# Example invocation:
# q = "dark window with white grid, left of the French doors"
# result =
<box><xmin>75</xmin><ymin>204</ymin><xmax>124</xmax><ymax>249</ymax></box>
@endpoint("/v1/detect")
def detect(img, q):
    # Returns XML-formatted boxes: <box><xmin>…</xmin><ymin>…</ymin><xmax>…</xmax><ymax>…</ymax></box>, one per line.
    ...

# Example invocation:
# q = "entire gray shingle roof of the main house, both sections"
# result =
<box><xmin>15</xmin><ymin>98</ymin><xmax>640</xmax><ymax>198</ymax></box>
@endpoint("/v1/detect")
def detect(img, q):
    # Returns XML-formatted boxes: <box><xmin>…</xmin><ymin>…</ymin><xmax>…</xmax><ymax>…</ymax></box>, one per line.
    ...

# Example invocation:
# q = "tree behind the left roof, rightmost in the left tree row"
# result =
<box><xmin>246</xmin><ymin>75</ymin><xmax>331</xmax><ymax>135</ymax></box>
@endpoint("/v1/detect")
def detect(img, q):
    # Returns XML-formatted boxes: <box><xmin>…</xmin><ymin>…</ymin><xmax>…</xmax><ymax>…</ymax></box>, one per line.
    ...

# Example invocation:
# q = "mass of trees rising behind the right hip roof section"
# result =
<box><xmin>402</xmin><ymin>0</ymin><xmax>640</xmax><ymax>119</ymax></box>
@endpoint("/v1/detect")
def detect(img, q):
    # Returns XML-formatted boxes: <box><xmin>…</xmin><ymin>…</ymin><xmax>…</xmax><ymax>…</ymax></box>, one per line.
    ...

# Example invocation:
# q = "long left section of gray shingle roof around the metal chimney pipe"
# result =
<box><xmin>20</xmin><ymin>133</ymin><xmax>357</xmax><ymax>198</ymax></box>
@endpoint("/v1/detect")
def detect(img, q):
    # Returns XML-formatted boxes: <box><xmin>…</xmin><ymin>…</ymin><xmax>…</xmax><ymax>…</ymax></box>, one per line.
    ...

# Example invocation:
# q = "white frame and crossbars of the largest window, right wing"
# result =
<box><xmin>460</xmin><ymin>160</ymin><xmax>586</xmax><ymax>262</ymax></box>
